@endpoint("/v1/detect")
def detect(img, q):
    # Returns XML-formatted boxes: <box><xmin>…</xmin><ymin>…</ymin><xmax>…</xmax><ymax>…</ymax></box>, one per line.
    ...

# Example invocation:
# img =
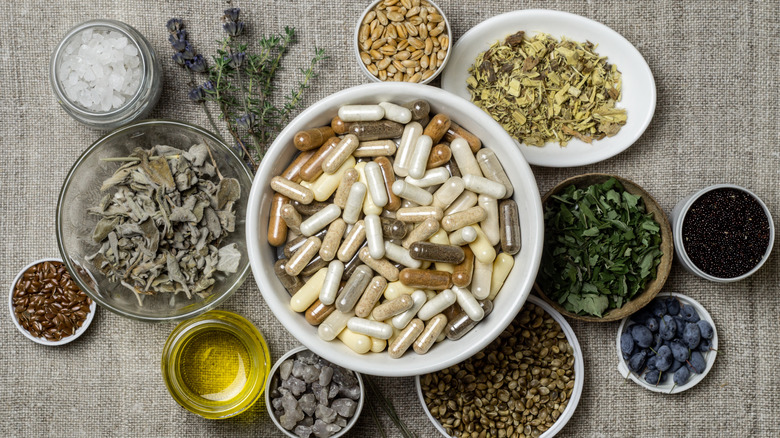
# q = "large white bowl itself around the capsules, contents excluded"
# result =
<box><xmin>246</xmin><ymin>83</ymin><xmax>544</xmax><ymax>376</ymax></box>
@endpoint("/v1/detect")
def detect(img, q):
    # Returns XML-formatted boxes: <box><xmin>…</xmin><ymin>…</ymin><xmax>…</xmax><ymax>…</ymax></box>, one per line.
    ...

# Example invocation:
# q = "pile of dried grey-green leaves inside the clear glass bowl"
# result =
<box><xmin>87</xmin><ymin>144</ymin><xmax>242</xmax><ymax>305</ymax></box>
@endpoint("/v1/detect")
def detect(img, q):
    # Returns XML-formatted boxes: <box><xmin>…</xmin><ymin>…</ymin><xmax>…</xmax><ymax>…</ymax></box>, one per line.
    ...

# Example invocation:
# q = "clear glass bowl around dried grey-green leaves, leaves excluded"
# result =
<box><xmin>56</xmin><ymin>120</ymin><xmax>252</xmax><ymax>321</ymax></box>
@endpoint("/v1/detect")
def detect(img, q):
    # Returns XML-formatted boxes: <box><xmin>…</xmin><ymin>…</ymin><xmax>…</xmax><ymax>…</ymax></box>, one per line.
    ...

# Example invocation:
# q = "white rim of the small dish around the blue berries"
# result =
<box><xmin>616</xmin><ymin>292</ymin><xmax>718</xmax><ymax>394</ymax></box>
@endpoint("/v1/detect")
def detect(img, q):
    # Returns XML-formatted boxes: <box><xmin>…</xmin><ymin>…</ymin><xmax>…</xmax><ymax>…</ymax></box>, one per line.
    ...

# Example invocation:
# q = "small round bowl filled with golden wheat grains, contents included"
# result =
<box><xmin>354</xmin><ymin>0</ymin><xmax>452</xmax><ymax>84</ymax></box>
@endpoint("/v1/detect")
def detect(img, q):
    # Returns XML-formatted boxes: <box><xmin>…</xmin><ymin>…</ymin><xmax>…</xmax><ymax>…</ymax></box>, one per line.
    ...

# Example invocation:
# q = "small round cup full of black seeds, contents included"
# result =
<box><xmin>671</xmin><ymin>184</ymin><xmax>775</xmax><ymax>282</ymax></box>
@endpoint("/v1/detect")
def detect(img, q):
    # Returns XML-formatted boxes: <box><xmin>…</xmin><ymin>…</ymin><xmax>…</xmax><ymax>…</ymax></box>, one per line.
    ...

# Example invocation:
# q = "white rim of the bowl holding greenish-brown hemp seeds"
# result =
<box><xmin>414</xmin><ymin>295</ymin><xmax>585</xmax><ymax>438</ymax></box>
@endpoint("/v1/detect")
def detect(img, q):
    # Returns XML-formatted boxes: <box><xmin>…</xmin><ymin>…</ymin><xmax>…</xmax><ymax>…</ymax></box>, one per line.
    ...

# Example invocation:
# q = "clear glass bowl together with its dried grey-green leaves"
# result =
<box><xmin>56</xmin><ymin>120</ymin><xmax>252</xmax><ymax>321</ymax></box>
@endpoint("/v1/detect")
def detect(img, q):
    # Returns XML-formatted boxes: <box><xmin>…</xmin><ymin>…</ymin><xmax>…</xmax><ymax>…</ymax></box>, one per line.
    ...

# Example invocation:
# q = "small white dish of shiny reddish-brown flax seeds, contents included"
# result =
<box><xmin>8</xmin><ymin>258</ymin><xmax>97</xmax><ymax>346</ymax></box>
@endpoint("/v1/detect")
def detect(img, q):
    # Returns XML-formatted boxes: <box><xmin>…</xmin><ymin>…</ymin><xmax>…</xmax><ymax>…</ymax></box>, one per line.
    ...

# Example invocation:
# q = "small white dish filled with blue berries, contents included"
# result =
<box><xmin>617</xmin><ymin>293</ymin><xmax>718</xmax><ymax>394</ymax></box>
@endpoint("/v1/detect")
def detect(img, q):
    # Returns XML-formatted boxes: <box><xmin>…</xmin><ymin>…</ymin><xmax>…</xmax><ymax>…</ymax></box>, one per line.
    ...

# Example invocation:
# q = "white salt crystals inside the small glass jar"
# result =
<box><xmin>58</xmin><ymin>29</ymin><xmax>142</xmax><ymax>112</ymax></box>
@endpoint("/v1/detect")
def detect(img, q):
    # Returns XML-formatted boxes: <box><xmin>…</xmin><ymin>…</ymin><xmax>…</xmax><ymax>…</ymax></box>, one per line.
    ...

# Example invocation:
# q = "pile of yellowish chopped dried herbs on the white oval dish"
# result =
<box><xmin>466</xmin><ymin>31</ymin><xmax>627</xmax><ymax>146</ymax></box>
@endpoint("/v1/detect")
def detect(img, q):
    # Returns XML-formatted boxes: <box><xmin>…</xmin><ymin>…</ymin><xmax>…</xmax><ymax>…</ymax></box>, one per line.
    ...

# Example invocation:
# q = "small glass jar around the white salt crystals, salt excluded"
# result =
<box><xmin>49</xmin><ymin>20</ymin><xmax>162</xmax><ymax>129</ymax></box>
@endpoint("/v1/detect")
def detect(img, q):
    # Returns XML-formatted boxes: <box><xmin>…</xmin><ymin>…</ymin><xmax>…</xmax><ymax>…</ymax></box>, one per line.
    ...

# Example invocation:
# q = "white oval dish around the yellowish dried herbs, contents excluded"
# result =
<box><xmin>441</xmin><ymin>9</ymin><xmax>657</xmax><ymax>167</ymax></box>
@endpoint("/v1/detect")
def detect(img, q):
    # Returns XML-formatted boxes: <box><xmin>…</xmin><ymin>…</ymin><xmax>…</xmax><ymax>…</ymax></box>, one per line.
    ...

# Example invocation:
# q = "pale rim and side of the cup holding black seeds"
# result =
<box><xmin>670</xmin><ymin>184</ymin><xmax>775</xmax><ymax>283</ymax></box>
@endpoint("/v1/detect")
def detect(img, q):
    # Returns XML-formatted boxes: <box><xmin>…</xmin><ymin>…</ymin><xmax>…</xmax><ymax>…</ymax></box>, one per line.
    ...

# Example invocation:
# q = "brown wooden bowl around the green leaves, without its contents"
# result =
<box><xmin>534</xmin><ymin>173</ymin><xmax>674</xmax><ymax>322</ymax></box>
